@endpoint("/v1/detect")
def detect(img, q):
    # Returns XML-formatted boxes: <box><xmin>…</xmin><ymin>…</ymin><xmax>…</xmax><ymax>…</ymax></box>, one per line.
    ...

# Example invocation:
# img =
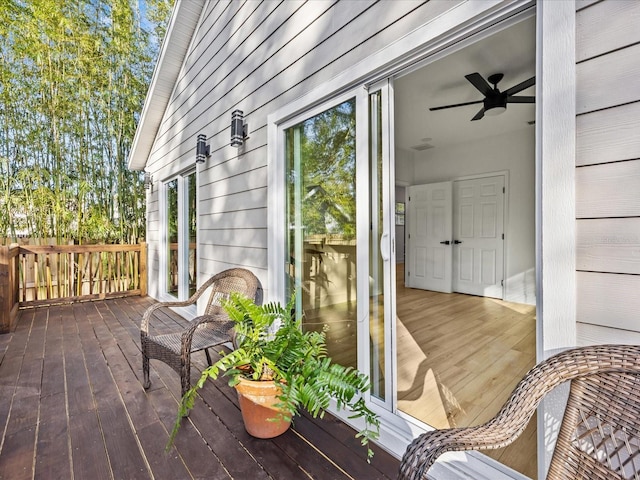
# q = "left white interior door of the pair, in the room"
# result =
<box><xmin>407</xmin><ymin>182</ymin><xmax>453</xmax><ymax>293</ymax></box>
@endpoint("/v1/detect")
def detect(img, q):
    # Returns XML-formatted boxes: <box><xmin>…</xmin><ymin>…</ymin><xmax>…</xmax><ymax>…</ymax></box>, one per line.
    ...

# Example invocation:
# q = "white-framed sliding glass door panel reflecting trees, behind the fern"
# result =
<box><xmin>283</xmin><ymin>82</ymin><xmax>395</xmax><ymax>410</ymax></box>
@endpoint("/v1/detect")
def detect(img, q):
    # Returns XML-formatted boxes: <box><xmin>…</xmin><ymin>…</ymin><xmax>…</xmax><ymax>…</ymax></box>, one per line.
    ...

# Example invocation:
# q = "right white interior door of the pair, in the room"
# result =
<box><xmin>453</xmin><ymin>175</ymin><xmax>504</xmax><ymax>298</ymax></box>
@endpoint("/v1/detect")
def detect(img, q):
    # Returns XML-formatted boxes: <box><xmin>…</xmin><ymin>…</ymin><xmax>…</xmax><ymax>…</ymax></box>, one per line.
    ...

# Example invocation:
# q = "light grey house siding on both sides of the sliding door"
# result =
<box><xmin>136</xmin><ymin>0</ymin><xmax>640</xmax><ymax>478</ymax></box>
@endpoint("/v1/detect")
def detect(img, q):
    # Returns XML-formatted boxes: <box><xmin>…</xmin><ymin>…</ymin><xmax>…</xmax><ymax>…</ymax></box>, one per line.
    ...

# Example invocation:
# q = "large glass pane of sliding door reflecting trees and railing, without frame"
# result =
<box><xmin>285</xmin><ymin>99</ymin><xmax>357</xmax><ymax>367</ymax></box>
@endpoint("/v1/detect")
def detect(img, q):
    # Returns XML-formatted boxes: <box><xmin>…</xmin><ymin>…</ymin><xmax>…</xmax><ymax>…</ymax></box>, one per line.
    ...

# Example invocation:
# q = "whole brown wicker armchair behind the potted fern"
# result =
<box><xmin>140</xmin><ymin>268</ymin><xmax>262</xmax><ymax>395</ymax></box>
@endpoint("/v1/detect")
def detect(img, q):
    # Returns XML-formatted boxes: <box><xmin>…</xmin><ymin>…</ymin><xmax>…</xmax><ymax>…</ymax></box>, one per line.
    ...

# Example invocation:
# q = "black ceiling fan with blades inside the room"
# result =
<box><xmin>429</xmin><ymin>72</ymin><xmax>536</xmax><ymax>121</ymax></box>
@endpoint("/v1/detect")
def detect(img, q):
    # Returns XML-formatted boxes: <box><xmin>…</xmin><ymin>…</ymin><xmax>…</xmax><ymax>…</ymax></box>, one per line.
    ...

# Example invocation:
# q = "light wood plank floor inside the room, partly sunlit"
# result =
<box><xmin>396</xmin><ymin>264</ymin><xmax>537</xmax><ymax>478</ymax></box>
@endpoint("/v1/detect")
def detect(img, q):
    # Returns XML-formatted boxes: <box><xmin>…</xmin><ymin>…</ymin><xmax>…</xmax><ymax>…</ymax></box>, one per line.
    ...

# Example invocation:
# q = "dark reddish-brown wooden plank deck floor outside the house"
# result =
<box><xmin>0</xmin><ymin>297</ymin><xmax>399</xmax><ymax>480</ymax></box>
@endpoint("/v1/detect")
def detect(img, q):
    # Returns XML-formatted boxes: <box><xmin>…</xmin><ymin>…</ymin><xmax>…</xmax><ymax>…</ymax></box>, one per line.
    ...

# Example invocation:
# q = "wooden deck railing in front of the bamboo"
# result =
<box><xmin>0</xmin><ymin>243</ymin><xmax>147</xmax><ymax>333</ymax></box>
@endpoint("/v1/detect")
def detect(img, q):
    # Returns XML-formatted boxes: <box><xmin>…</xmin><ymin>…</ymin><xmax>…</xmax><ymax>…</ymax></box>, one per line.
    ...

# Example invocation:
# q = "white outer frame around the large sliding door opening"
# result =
<box><xmin>265</xmin><ymin>0</ymin><xmax>576</xmax><ymax>478</ymax></box>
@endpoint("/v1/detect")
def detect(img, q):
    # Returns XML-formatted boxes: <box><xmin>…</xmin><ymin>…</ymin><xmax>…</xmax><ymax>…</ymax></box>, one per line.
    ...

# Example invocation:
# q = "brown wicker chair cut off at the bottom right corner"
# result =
<box><xmin>399</xmin><ymin>345</ymin><xmax>640</xmax><ymax>480</ymax></box>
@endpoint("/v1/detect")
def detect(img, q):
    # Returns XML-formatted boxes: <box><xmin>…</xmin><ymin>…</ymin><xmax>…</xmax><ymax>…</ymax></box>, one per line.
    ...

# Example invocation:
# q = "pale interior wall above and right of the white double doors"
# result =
<box><xmin>404</xmin><ymin>126</ymin><xmax>535</xmax><ymax>305</ymax></box>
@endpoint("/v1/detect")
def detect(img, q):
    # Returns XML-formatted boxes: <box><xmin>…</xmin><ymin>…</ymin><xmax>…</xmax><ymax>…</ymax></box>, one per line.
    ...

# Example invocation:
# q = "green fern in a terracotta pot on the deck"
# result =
<box><xmin>169</xmin><ymin>294</ymin><xmax>379</xmax><ymax>458</ymax></box>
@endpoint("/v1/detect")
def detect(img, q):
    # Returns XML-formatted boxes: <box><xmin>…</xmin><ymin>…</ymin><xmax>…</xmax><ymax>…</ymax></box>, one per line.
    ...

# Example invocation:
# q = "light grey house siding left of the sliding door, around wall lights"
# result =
<box><xmin>146</xmin><ymin>0</ymin><xmax>464</xmax><ymax>298</ymax></box>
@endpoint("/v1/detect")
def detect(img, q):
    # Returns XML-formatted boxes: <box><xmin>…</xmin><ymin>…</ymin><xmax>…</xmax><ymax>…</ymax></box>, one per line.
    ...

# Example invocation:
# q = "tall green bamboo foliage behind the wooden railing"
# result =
<box><xmin>0</xmin><ymin>0</ymin><xmax>173</xmax><ymax>242</ymax></box>
